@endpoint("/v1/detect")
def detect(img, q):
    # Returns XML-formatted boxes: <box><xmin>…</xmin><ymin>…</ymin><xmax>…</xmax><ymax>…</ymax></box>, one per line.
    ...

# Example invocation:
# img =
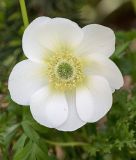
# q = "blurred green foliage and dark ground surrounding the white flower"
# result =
<box><xmin>0</xmin><ymin>0</ymin><xmax>136</xmax><ymax>160</ymax></box>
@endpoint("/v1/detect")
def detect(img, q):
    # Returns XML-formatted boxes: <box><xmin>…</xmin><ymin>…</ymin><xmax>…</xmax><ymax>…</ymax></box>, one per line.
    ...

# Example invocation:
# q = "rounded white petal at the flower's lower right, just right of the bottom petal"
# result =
<box><xmin>76</xmin><ymin>76</ymin><xmax>112</xmax><ymax>122</ymax></box>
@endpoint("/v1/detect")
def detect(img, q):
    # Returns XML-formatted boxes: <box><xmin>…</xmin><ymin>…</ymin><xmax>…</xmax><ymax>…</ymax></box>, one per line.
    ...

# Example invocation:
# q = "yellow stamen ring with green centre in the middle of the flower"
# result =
<box><xmin>47</xmin><ymin>53</ymin><xmax>85</xmax><ymax>91</ymax></box>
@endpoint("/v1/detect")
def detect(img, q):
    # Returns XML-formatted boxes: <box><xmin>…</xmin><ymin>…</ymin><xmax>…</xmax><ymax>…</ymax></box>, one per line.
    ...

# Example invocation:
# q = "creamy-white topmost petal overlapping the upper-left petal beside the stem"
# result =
<box><xmin>37</xmin><ymin>18</ymin><xmax>83</xmax><ymax>51</ymax></box>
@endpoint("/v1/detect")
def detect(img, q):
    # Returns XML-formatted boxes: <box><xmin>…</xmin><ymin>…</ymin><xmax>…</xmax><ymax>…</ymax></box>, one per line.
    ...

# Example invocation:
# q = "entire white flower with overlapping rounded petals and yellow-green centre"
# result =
<box><xmin>8</xmin><ymin>17</ymin><xmax>123</xmax><ymax>131</ymax></box>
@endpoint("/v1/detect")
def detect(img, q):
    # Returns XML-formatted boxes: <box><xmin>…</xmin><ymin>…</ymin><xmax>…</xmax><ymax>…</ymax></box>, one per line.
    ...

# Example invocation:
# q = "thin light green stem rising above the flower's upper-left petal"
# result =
<box><xmin>19</xmin><ymin>0</ymin><xmax>29</xmax><ymax>28</ymax></box>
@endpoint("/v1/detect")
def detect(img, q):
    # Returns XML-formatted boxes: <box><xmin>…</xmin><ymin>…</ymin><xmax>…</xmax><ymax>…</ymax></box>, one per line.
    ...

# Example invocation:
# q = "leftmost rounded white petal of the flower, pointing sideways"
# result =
<box><xmin>8</xmin><ymin>60</ymin><xmax>47</xmax><ymax>105</ymax></box>
